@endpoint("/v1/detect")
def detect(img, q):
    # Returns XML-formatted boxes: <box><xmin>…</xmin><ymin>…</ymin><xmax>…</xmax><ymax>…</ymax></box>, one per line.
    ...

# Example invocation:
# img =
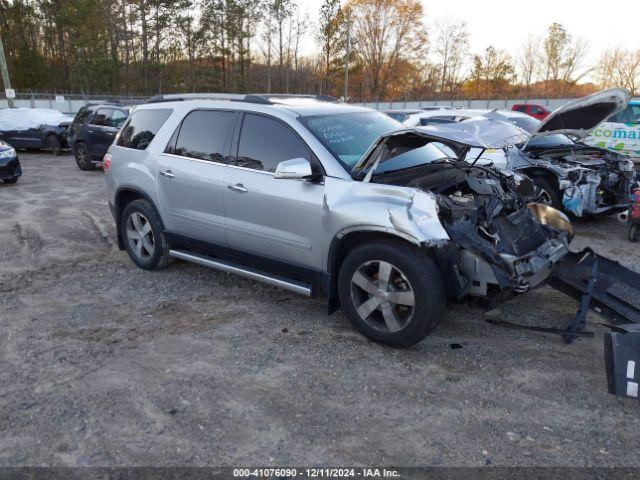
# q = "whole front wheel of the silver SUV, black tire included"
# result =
<box><xmin>338</xmin><ymin>241</ymin><xmax>446</xmax><ymax>348</ymax></box>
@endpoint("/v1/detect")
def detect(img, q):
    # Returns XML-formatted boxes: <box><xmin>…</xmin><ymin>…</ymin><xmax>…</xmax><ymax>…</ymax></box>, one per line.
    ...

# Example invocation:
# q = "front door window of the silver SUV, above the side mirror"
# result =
<box><xmin>238</xmin><ymin>114</ymin><xmax>312</xmax><ymax>172</ymax></box>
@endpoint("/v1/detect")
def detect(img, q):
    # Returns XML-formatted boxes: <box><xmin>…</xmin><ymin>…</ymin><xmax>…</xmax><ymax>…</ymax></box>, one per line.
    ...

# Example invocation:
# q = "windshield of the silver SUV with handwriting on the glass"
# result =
<box><xmin>300</xmin><ymin>112</ymin><xmax>404</xmax><ymax>173</ymax></box>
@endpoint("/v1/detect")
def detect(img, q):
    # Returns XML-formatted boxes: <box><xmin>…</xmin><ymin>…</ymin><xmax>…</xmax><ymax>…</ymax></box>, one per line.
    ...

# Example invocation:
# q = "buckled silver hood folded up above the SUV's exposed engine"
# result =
<box><xmin>352</xmin><ymin>117</ymin><xmax>530</xmax><ymax>182</ymax></box>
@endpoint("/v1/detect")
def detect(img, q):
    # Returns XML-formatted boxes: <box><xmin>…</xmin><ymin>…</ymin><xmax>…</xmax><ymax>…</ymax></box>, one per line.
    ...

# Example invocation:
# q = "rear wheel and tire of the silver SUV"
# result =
<box><xmin>120</xmin><ymin>200</ymin><xmax>171</xmax><ymax>270</ymax></box>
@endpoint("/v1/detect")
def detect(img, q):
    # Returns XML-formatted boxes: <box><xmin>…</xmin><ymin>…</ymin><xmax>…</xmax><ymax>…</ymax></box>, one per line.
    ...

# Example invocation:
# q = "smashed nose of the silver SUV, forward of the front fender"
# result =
<box><xmin>420</xmin><ymin>167</ymin><xmax>572</xmax><ymax>298</ymax></box>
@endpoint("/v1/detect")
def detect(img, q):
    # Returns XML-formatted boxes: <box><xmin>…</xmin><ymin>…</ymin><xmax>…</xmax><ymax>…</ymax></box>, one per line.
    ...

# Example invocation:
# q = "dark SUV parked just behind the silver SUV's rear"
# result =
<box><xmin>67</xmin><ymin>104</ymin><xmax>131</xmax><ymax>170</ymax></box>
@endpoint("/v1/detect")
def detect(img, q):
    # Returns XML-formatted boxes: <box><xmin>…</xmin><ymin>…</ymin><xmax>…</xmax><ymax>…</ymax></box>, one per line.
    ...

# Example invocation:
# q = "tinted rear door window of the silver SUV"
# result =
<box><xmin>167</xmin><ymin>110</ymin><xmax>235</xmax><ymax>163</ymax></box>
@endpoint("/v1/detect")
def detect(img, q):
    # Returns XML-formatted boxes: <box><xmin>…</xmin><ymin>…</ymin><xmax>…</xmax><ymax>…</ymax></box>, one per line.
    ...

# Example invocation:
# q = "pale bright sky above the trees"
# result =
<box><xmin>301</xmin><ymin>0</ymin><xmax>640</xmax><ymax>73</ymax></box>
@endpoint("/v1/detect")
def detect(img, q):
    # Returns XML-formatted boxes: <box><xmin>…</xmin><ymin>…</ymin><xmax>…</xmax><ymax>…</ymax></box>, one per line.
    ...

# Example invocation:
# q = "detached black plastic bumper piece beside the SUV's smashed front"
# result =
<box><xmin>549</xmin><ymin>249</ymin><xmax>640</xmax><ymax>324</ymax></box>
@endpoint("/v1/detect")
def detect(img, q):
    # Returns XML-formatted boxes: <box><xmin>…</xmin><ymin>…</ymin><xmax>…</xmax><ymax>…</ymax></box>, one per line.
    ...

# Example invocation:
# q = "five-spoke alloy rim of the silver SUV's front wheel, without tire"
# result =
<box><xmin>351</xmin><ymin>260</ymin><xmax>415</xmax><ymax>333</ymax></box>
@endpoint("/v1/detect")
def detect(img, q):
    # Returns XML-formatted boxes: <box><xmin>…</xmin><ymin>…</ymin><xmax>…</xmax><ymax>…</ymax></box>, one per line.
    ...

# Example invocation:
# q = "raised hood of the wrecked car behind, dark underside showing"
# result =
<box><xmin>533</xmin><ymin>88</ymin><xmax>631</xmax><ymax>140</ymax></box>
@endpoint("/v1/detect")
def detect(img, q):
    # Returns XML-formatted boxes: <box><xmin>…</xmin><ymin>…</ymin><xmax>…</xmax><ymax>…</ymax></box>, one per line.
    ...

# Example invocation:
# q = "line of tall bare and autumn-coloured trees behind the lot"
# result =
<box><xmin>0</xmin><ymin>0</ymin><xmax>640</xmax><ymax>101</ymax></box>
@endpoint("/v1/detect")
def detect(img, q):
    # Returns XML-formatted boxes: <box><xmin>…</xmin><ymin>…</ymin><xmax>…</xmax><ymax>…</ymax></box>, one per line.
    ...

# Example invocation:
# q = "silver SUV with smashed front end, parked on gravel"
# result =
<box><xmin>104</xmin><ymin>94</ymin><xmax>572</xmax><ymax>347</ymax></box>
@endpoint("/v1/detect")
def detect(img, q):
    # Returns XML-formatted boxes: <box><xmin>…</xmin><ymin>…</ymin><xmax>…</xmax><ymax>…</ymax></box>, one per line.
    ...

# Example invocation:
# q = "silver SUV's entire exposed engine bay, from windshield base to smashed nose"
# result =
<box><xmin>372</xmin><ymin>160</ymin><xmax>572</xmax><ymax>298</ymax></box>
